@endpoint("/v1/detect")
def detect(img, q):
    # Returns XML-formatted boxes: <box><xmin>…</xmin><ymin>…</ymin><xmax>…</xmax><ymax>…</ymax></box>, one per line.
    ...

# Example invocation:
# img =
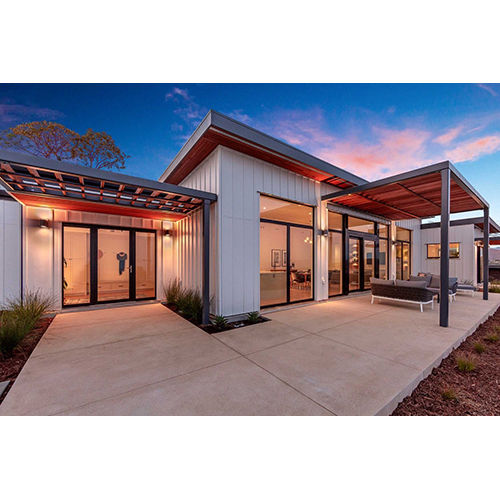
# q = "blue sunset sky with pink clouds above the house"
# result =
<box><xmin>0</xmin><ymin>83</ymin><xmax>500</xmax><ymax>221</ymax></box>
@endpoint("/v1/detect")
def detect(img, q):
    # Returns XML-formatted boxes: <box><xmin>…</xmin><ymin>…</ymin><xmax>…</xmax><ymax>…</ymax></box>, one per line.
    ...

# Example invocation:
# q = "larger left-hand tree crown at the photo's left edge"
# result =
<box><xmin>0</xmin><ymin>121</ymin><xmax>78</xmax><ymax>161</ymax></box>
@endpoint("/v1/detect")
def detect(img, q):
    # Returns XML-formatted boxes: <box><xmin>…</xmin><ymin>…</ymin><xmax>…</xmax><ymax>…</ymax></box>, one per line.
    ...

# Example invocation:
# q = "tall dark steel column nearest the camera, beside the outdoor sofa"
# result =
<box><xmin>439</xmin><ymin>168</ymin><xmax>450</xmax><ymax>327</ymax></box>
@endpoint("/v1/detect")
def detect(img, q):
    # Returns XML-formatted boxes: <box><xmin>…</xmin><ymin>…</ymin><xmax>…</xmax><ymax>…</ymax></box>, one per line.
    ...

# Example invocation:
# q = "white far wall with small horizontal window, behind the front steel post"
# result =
<box><xmin>421</xmin><ymin>224</ymin><xmax>477</xmax><ymax>283</ymax></box>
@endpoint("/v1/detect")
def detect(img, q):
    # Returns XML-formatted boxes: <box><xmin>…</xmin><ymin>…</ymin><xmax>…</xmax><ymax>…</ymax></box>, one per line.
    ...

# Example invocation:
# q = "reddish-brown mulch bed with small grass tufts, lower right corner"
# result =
<box><xmin>393</xmin><ymin>309</ymin><xmax>500</xmax><ymax>415</ymax></box>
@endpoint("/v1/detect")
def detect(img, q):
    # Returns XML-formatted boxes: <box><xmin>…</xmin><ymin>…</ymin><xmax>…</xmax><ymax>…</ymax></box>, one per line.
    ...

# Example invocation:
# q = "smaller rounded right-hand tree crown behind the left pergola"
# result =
<box><xmin>73</xmin><ymin>129</ymin><xmax>129</xmax><ymax>170</ymax></box>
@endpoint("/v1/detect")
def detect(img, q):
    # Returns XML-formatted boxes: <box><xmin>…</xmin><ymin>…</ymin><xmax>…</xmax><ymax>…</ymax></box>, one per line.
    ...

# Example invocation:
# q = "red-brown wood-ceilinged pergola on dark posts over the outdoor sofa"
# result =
<box><xmin>322</xmin><ymin>161</ymin><xmax>490</xmax><ymax>327</ymax></box>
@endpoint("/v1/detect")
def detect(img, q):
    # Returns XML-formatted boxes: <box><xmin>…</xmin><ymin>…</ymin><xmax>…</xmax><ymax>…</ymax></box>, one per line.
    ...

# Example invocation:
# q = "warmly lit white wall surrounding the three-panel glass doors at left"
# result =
<box><xmin>23</xmin><ymin>207</ymin><xmax>164</xmax><ymax>309</ymax></box>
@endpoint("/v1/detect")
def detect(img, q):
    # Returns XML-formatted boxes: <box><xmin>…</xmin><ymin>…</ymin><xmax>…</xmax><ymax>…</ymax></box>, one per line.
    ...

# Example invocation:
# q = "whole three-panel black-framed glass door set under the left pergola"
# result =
<box><xmin>62</xmin><ymin>224</ymin><xmax>156</xmax><ymax>306</ymax></box>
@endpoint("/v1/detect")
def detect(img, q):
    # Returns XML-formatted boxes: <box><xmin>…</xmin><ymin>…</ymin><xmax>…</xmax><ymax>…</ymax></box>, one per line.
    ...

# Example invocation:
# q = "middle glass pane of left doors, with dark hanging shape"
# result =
<box><xmin>97</xmin><ymin>229</ymin><xmax>130</xmax><ymax>301</ymax></box>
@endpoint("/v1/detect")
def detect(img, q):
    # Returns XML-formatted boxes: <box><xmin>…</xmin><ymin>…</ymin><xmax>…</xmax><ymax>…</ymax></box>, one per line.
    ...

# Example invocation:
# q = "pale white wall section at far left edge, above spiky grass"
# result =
<box><xmin>0</xmin><ymin>199</ymin><xmax>22</xmax><ymax>309</ymax></box>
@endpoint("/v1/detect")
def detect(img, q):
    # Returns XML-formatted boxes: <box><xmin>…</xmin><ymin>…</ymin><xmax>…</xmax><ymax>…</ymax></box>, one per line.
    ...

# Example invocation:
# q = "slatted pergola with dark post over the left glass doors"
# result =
<box><xmin>0</xmin><ymin>150</ymin><xmax>217</xmax><ymax>323</ymax></box>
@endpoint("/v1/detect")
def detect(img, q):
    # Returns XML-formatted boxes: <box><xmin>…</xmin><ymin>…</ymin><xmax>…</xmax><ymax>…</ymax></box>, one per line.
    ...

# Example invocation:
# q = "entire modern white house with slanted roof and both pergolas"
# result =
<box><xmin>0</xmin><ymin>111</ymin><xmax>500</xmax><ymax>326</ymax></box>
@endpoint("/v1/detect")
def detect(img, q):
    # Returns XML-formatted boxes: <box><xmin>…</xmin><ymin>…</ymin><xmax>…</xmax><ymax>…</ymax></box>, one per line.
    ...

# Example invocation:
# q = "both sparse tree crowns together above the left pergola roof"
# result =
<box><xmin>0</xmin><ymin>121</ymin><xmax>129</xmax><ymax>170</ymax></box>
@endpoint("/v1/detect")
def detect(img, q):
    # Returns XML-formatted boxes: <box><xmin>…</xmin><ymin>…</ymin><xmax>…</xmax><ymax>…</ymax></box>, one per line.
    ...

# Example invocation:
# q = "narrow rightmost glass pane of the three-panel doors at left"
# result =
<box><xmin>135</xmin><ymin>232</ymin><xmax>156</xmax><ymax>299</ymax></box>
